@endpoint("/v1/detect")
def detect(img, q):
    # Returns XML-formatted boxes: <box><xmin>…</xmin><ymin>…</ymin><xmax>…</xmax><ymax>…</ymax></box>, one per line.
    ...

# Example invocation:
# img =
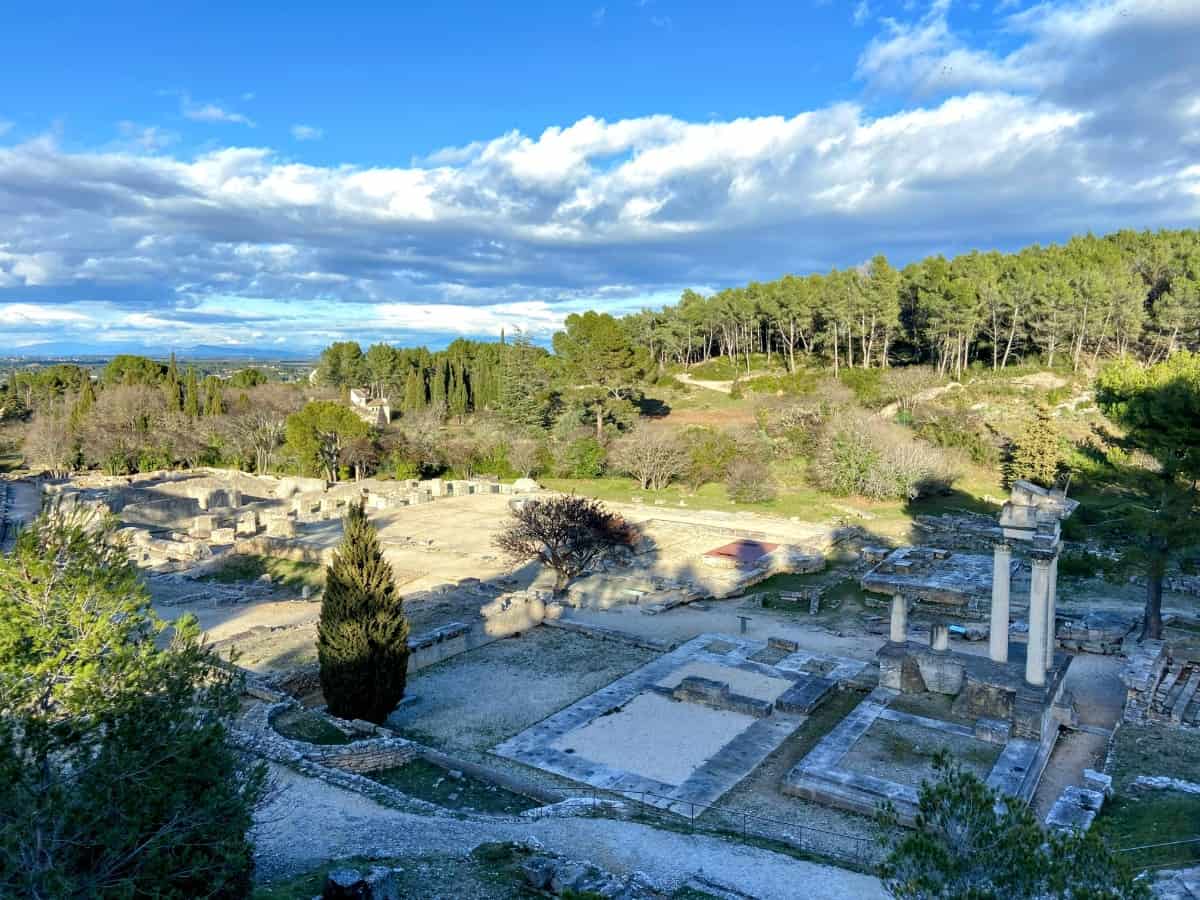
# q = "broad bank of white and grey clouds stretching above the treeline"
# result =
<box><xmin>7</xmin><ymin>0</ymin><xmax>1200</xmax><ymax>344</ymax></box>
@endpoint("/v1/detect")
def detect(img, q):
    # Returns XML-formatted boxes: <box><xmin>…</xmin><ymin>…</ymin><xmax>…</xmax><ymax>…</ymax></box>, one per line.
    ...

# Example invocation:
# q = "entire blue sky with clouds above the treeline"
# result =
<box><xmin>0</xmin><ymin>0</ymin><xmax>1200</xmax><ymax>355</ymax></box>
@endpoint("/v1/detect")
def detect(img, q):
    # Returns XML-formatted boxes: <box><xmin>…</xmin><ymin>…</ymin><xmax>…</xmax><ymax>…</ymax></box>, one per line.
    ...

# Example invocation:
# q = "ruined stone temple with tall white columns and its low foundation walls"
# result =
<box><xmin>784</xmin><ymin>481</ymin><xmax>1084</xmax><ymax>821</ymax></box>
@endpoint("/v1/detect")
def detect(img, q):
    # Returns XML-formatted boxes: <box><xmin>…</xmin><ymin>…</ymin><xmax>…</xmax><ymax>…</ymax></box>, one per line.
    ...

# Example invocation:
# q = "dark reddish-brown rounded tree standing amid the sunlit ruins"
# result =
<box><xmin>496</xmin><ymin>494</ymin><xmax>637</xmax><ymax>594</ymax></box>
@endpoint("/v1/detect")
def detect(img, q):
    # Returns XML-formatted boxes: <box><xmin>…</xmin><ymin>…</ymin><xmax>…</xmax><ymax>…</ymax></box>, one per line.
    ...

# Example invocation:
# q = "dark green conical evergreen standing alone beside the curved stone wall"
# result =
<box><xmin>317</xmin><ymin>504</ymin><xmax>408</xmax><ymax>724</ymax></box>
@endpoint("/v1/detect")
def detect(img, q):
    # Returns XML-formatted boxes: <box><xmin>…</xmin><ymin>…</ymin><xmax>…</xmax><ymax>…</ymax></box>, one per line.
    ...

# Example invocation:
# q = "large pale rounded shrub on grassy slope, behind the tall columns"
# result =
<box><xmin>809</xmin><ymin>415</ymin><xmax>956</xmax><ymax>500</ymax></box>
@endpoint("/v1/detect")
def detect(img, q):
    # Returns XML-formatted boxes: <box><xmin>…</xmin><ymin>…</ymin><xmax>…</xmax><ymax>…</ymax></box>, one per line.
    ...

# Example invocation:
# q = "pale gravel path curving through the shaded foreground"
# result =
<box><xmin>254</xmin><ymin>766</ymin><xmax>887</xmax><ymax>900</ymax></box>
